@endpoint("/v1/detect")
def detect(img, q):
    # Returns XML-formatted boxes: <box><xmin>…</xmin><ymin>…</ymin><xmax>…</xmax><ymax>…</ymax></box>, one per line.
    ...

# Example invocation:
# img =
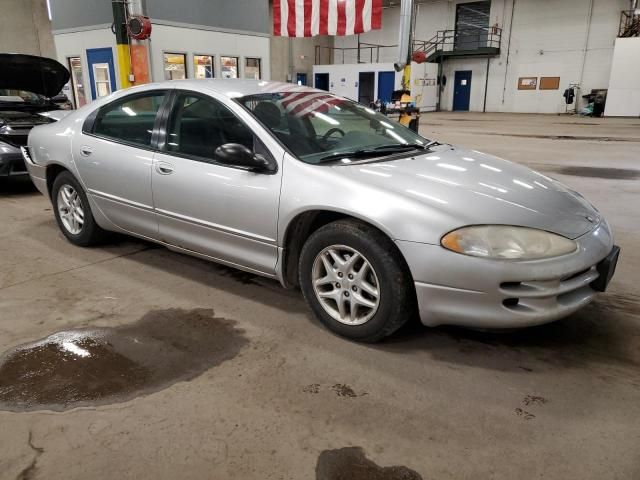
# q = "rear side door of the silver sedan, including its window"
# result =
<box><xmin>72</xmin><ymin>90</ymin><xmax>167</xmax><ymax>238</ymax></box>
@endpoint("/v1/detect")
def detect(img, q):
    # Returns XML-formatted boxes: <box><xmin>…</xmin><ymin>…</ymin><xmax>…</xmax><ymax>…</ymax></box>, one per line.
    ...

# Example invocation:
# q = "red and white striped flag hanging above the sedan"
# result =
<box><xmin>273</xmin><ymin>0</ymin><xmax>382</xmax><ymax>37</ymax></box>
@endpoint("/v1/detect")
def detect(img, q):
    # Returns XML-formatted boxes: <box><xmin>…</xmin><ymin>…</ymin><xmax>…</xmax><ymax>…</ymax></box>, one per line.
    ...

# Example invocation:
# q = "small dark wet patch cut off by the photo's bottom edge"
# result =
<box><xmin>316</xmin><ymin>447</ymin><xmax>422</xmax><ymax>480</ymax></box>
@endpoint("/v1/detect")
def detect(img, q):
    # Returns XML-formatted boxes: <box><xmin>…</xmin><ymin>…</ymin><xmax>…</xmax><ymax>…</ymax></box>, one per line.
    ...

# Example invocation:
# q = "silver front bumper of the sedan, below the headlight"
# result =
<box><xmin>396</xmin><ymin>220</ymin><xmax>617</xmax><ymax>328</ymax></box>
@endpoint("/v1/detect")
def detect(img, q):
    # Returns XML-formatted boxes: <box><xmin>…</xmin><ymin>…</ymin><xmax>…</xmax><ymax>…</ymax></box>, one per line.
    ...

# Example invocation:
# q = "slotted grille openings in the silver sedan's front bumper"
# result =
<box><xmin>500</xmin><ymin>265</ymin><xmax>600</xmax><ymax>313</ymax></box>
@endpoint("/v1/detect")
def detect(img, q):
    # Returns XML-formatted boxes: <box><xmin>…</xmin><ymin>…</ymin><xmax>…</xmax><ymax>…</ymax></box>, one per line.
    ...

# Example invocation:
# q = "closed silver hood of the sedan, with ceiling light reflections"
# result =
<box><xmin>340</xmin><ymin>145</ymin><xmax>600</xmax><ymax>239</ymax></box>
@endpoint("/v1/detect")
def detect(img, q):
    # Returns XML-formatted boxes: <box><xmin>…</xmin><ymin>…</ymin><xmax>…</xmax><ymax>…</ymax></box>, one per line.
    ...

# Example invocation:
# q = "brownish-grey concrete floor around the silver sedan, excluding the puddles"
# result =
<box><xmin>0</xmin><ymin>113</ymin><xmax>640</xmax><ymax>480</ymax></box>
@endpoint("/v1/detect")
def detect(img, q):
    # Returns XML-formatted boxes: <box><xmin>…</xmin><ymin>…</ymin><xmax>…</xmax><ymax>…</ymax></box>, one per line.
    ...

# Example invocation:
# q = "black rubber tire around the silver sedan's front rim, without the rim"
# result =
<box><xmin>298</xmin><ymin>220</ymin><xmax>416</xmax><ymax>343</ymax></box>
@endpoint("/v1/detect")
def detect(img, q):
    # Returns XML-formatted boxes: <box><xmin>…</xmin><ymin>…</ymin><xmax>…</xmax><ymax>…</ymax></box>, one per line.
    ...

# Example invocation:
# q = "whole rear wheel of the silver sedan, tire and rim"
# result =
<box><xmin>51</xmin><ymin>172</ymin><xmax>106</xmax><ymax>247</ymax></box>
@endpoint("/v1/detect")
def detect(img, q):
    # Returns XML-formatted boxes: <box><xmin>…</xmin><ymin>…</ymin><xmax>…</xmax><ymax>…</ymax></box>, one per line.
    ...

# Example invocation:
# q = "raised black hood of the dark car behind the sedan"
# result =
<box><xmin>0</xmin><ymin>53</ymin><xmax>69</xmax><ymax>97</ymax></box>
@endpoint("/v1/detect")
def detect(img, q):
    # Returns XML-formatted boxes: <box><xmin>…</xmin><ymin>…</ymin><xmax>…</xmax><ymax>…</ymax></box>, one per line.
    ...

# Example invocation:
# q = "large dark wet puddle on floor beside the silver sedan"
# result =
<box><xmin>0</xmin><ymin>309</ymin><xmax>248</xmax><ymax>411</ymax></box>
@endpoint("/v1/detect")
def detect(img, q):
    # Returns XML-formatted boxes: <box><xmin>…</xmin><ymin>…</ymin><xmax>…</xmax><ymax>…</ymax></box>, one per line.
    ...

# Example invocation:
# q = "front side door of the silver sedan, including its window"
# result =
<box><xmin>153</xmin><ymin>92</ymin><xmax>282</xmax><ymax>275</ymax></box>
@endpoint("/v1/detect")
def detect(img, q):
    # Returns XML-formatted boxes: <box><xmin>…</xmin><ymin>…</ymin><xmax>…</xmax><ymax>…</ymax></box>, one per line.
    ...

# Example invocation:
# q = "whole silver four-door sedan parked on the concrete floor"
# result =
<box><xmin>23</xmin><ymin>80</ymin><xmax>619</xmax><ymax>341</ymax></box>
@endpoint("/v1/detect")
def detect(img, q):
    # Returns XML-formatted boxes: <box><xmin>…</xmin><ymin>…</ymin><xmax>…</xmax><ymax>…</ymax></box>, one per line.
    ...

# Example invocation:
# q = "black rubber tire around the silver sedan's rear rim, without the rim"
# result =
<box><xmin>51</xmin><ymin>171</ymin><xmax>107</xmax><ymax>247</ymax></box>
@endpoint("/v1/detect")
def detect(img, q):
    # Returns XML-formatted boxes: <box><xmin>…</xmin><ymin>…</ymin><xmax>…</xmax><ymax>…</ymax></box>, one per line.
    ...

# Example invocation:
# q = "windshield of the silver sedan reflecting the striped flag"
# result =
<box><xmin>238</xmin><ymin>91</ymin><xmax>429</xmax><ymax>164</ymax></box>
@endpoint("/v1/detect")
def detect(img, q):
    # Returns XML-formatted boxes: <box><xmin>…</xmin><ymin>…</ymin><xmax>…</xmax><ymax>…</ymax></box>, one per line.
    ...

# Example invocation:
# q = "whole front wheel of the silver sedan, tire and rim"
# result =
<box><xmin>299</xmin><ymin>220</ymin><xmax>415</xmax><ymax>342</ymax></box>
